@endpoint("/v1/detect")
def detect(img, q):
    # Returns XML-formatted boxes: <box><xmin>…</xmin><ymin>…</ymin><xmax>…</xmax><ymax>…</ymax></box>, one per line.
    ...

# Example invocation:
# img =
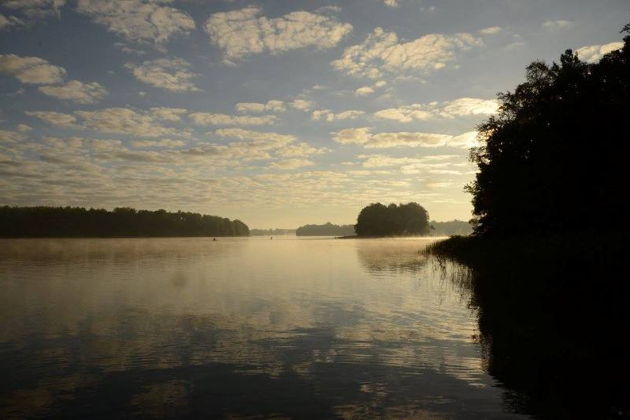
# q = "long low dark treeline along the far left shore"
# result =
<box><xmin>0</xmin><ymin>206</ymin><xmax>249</xmax><ymax>238</ymax></box>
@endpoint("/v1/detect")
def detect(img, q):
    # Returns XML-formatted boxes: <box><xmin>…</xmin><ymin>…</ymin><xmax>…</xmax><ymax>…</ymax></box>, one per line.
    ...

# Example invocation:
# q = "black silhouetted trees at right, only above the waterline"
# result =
<box><xmin>468</xmin><ymin>27</ymin><xmax>630</xmax><ymax>237</ymax></box>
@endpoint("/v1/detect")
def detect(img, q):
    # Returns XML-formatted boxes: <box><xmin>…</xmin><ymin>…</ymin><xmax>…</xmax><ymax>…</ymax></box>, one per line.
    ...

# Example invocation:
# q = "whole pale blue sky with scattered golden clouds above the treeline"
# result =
<box><xmin>0</xmin><ymin>0</ymin><xmax>630</xmax><ymax>228</ymax></box>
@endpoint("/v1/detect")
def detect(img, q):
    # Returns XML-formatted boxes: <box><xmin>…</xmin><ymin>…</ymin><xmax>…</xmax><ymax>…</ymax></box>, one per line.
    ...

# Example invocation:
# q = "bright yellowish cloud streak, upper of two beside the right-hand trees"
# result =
<box><xmin>374</xmin><ymin>98</ymin><xmax>499</xmax><ymax>123</ymax></box>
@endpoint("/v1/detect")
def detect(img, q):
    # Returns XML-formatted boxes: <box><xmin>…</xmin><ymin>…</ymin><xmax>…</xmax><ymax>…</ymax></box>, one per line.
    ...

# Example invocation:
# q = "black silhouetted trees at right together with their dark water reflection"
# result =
<box><xmin>427</xmin><ymin>25</ymin><xmax>630</xmax><ymax>419</ymax></box>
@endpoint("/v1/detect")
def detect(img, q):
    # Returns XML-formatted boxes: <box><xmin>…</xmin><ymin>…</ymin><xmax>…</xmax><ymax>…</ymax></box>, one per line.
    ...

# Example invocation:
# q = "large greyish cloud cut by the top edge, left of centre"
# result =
<box><xmin>77</xmin><ymin>0</ymin><xmax>195</xmax><ymax>45</ymax></box>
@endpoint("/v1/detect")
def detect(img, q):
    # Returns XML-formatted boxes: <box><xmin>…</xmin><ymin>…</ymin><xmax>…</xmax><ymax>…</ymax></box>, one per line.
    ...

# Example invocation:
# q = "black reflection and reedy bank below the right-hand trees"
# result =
<box><xmin>428</xmin><ymin>233</ymin><xmax>630</xmax><ymax>419</ymax></box>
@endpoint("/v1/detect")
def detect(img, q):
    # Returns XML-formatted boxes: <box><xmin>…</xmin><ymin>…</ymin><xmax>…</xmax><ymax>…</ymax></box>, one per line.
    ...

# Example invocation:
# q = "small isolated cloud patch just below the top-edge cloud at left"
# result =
<box><xmin>125</xmin><ymin>58</ymin><xmax>200</xmax><ymax>92</ymax></box>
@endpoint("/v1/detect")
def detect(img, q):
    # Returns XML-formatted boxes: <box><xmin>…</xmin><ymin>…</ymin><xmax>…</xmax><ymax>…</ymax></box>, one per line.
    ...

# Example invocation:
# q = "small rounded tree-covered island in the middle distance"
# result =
<box><xmin>354</xmin><ymin>203</ymin><xmax>429</xmax><ymax>236</ymax></box>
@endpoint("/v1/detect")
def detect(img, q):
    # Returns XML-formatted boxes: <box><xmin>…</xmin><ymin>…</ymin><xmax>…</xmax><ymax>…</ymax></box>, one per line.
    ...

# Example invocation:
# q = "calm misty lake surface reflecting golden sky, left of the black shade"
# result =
<box><xmin>0</xmin><ymin>238</ymin><xmax>528</xmax><ymax>419</ymax></box>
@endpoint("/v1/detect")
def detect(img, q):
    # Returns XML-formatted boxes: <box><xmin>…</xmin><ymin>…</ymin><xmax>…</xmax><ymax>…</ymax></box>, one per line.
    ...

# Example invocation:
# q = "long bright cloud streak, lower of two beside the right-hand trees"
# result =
<box><xmin>333</xmin><ymin>127</ymin><xmax>477</xmax><ymax>149</ymax></box>
